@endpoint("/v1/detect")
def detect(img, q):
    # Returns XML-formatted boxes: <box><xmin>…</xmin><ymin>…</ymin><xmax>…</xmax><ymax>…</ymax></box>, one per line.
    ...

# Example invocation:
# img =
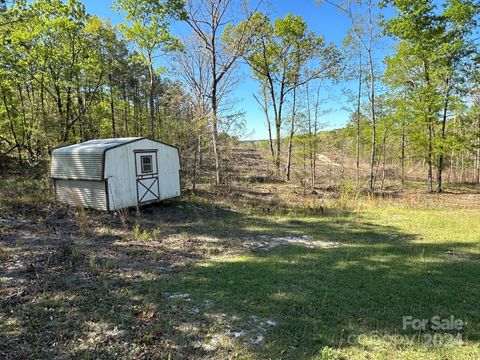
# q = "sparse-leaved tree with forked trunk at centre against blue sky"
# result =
<box><xmin>240</xmin><ymin>13</ymin><xmax>341</xmax><ymax>176</ymax></box>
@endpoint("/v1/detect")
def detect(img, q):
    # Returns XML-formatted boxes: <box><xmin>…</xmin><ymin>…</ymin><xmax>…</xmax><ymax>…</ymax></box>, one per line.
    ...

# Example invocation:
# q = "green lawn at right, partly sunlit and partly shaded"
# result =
<box><xmin>120</xmin><ymin>208</ymin><xmax>480</xmax><ymax>359</ymax></box>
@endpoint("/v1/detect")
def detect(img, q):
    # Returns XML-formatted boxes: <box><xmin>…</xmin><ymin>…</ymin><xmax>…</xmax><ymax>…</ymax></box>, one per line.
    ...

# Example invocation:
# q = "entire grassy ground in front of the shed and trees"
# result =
<box><xmin>0</xmin><ymin>176</ymin><xmax>480</xmax><ymax>359</ymax></box>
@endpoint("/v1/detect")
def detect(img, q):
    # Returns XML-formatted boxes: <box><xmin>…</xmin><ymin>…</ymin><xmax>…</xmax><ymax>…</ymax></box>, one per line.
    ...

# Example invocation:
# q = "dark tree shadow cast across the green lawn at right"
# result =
<box><xmin>125</xmin><ymin>211</ymin><xmax>480</xmax><ymax>358</ymax></box>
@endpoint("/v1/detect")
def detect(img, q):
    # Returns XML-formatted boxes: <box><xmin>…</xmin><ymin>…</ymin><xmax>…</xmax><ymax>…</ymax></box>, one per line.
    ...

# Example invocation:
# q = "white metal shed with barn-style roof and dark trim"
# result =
<box><xmin>50</xmin><ymin>137</ymin><xmax>180</xmax><ymax>211</ymax></box>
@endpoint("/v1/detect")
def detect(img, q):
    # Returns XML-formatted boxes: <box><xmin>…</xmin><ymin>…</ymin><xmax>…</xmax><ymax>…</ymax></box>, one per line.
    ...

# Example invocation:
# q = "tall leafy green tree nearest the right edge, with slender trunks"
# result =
<box><xmin>385</xmin><ymin>0</ymin><xmax>479</xmax><ymax>191</ymax></box>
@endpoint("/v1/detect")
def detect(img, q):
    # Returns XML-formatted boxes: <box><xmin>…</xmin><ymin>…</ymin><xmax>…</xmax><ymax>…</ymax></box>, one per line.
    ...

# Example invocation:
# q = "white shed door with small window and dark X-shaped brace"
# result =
<box><xmin>135</xmin><ymin>150</ymin><xmax>160</xmax><ymax>204</ymax></box>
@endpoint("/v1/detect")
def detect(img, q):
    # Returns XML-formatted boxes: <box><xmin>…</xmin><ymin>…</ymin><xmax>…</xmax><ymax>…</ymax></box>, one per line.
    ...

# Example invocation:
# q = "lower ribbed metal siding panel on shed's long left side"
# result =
<box><xmin>55</xmin><ymin>180</ymin><xmax>107</xmax><ymax>210</ymax></box>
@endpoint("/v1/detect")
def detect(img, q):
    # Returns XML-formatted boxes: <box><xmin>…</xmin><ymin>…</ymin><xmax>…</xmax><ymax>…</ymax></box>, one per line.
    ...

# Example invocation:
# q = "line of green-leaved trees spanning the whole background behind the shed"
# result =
<box><xmin>0</xmin><ymin>0</ymin><xmax>480</xmax><ymax>192</ymax></box>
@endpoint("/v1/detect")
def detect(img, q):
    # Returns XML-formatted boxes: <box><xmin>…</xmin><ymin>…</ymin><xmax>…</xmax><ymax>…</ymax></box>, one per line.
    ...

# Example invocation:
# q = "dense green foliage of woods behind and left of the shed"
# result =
<box><xmin>0</xmin><ymin>0</ymin><xmax>201</xmax><ymax>177</ymax></box>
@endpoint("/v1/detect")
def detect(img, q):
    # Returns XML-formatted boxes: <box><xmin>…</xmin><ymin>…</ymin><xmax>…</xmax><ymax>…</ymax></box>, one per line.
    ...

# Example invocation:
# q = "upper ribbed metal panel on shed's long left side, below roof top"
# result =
<box><xmin>50</xmin><ymin>153</ymin><xmax>103</xmax><ymax>180</ymax></box>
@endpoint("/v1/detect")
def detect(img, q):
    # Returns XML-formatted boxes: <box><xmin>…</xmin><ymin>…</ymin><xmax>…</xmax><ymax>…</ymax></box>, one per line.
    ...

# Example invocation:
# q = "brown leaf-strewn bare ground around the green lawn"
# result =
<box><xmin>0</xmin><ymin>145</ymin><xmax>480</xmax><ymax>359</ymax></box>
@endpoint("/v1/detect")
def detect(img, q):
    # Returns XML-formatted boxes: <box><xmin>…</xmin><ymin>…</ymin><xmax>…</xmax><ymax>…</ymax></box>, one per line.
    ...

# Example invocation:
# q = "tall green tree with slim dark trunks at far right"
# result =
<box><xmin>387</xmin><ymin>0</ymin><xmax>478</xmax><ymax>192</ymax></box>
